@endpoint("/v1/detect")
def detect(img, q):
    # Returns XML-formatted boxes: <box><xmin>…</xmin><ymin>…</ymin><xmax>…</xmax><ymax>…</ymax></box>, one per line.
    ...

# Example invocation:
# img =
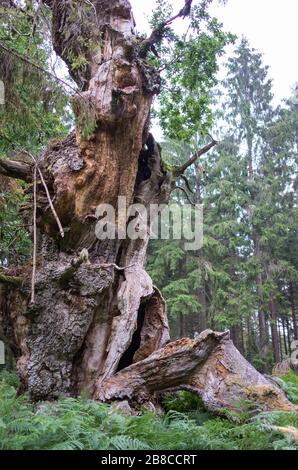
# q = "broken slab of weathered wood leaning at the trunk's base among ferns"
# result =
<box><xmin>94</xmin><ymin>330</ymin><xmax>297</xmax><ymax>412</ymax></box>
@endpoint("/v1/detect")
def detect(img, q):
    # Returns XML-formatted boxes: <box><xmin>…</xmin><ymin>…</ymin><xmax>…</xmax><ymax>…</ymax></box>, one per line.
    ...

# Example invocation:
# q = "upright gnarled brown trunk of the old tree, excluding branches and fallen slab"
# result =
<box><xmin>2</xmin><ymin>0</ymin><xmax>166</xmax><ymax>399</ymax></box>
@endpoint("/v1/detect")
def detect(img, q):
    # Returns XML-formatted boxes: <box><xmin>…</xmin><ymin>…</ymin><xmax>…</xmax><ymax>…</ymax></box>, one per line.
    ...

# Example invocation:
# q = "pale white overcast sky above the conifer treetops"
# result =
<box><xmin>131</xmin><ymin>0</ymin><xmax>298</xmax><ymax>103</ymax></box>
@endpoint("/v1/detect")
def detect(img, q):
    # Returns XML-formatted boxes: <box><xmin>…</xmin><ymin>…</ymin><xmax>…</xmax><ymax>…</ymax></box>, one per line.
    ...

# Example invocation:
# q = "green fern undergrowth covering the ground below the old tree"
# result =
<box><xmin>0</xmin><ymin>371</ymin><xmax>298</xmax><ymax>450</ymax></box>
